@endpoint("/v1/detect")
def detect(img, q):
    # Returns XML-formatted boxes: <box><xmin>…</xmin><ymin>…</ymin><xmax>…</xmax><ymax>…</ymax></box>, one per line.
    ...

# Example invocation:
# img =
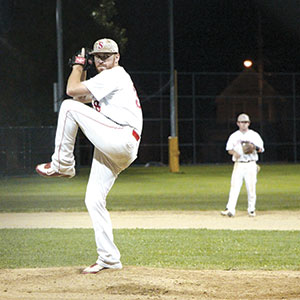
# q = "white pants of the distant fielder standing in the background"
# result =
<box><xmin>226</xmin><ymin>161</ymin><xmax>257</xmax><ymax>215</ymax></box>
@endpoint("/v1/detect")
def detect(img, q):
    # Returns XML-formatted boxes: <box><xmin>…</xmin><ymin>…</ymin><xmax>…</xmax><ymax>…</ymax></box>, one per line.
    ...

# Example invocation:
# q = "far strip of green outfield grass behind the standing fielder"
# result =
<box><xmin>0</xmin><ymin>164</ymin><xmax>300</xmax><ymax>212</ymax></box>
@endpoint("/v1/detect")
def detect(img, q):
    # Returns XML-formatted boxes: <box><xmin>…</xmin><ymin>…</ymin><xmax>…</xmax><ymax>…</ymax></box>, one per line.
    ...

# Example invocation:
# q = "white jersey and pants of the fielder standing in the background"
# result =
<box><xmin>226</xmin><ymin>129</ymin><xmax>264</xmax><ymax>215</ymax></box>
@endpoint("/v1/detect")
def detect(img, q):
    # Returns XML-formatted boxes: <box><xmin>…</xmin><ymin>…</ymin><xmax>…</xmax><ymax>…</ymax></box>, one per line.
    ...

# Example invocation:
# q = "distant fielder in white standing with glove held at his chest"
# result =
<box><xmin>221</xmin><ymin>114</ymin><xmax>264</xmax><ymax>217</ymax></box>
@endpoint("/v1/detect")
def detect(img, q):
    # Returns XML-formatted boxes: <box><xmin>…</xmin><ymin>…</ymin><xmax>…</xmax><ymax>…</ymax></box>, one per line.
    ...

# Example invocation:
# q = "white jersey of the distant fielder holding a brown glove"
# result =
<box><xmin>226</xmin><ymin>129</ymin><xmax>264</xmax><ymax>162</ymax></box>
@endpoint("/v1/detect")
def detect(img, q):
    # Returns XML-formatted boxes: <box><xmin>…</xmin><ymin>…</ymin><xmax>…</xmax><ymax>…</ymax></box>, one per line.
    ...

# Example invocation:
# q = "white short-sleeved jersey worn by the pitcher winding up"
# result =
<box><xmin>82</xmin><ymin>66</ymin><xmax>143</xmax><ymax>134</ymax></box>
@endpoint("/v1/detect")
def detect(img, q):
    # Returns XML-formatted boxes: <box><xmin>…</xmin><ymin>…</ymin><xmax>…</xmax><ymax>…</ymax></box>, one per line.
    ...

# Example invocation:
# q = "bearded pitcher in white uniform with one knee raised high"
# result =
<box><xmin>36</xmin><ymin>38</ymin><xmax>143</xmax><ymax>274</ymax></box>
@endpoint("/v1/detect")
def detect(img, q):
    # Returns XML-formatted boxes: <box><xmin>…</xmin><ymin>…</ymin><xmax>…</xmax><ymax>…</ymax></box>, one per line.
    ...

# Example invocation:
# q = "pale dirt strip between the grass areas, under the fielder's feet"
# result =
<box><xmin>0</xmin><ymin>211</ymin><xmax>300</xmax><ymax>230</ymax></box>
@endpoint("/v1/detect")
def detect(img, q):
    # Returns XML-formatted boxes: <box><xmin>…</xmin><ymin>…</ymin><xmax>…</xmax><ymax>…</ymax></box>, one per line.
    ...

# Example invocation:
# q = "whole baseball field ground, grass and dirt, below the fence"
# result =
<box><xmin>0</xmin><ymin>164</ymin><xmax>300</xmax><ymax>300</ymax></box>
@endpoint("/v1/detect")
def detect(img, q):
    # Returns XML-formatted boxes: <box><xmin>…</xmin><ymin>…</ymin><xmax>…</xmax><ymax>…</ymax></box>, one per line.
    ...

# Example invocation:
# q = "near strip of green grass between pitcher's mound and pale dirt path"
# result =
<box><xmin>0</xmin><ymin>229</ymin><xmax>300</xmax><ymax>270</ymax></box>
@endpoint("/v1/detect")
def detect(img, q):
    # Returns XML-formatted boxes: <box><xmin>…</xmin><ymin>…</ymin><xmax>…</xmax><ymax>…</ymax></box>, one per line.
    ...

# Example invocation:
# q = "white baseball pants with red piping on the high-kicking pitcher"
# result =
<box><xmin>52</xmin><ymin>100</ymin><xmax>140</xmax><ymax>268</ymax></box>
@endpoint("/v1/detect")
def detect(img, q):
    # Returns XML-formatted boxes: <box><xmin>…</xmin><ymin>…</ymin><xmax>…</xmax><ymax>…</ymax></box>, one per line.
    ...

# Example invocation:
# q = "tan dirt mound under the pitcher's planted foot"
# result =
<box><xmin>0</xmin><ymin>267</ymin><xmax>300</xmax><ymax>300</ymax></box>
